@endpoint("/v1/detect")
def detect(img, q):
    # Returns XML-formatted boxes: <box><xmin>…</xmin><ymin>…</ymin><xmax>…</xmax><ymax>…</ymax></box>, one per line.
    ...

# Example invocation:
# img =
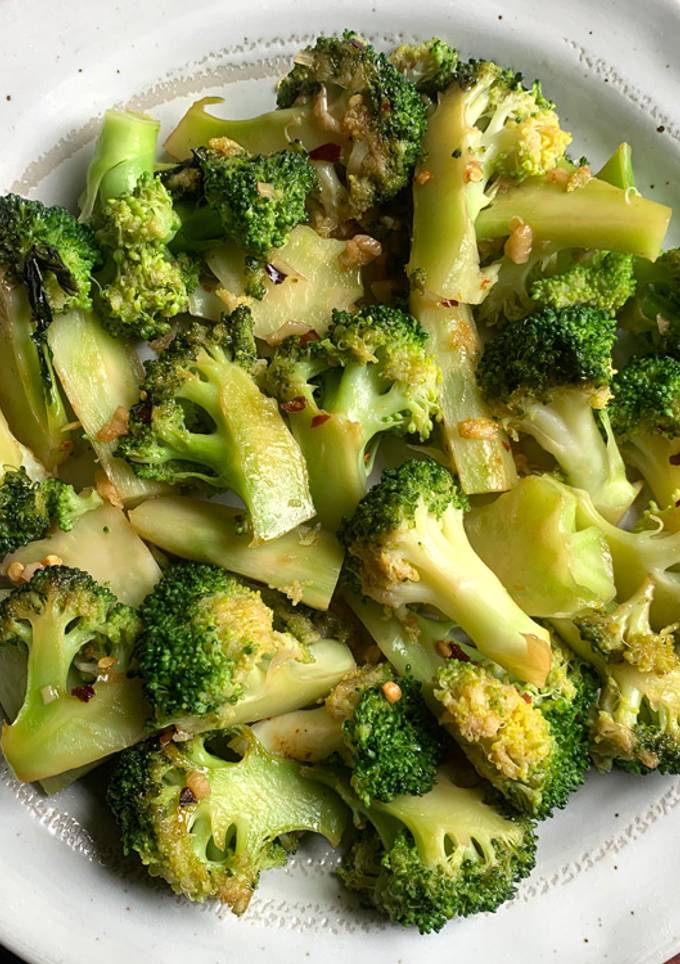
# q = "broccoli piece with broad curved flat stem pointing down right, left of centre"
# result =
<box><xmin>116</xmin><ymin>308</ymin><xmax>314</xmax><ymax>542</ymax></box>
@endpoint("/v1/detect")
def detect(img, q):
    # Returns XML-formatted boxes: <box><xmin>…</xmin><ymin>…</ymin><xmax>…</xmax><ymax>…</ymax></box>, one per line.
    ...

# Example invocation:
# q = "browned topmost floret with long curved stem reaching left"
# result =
<box><xmin>165</xmin><ymin>31</ymin><xmax>427</xmax><ymax>218</ymax></box>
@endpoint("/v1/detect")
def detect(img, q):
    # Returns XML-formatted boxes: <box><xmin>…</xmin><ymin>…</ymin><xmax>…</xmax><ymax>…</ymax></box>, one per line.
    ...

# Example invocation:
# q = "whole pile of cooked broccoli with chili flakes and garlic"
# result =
<box><xmin>0</xmin><ymin>29</ymin><xmax>680</xmax><ymax>934</ymax></box>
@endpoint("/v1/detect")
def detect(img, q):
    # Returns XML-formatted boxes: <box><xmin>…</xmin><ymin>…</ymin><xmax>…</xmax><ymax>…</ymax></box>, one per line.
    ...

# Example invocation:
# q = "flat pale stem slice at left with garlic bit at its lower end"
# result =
<box><xmin>48</xmin><ymin>311</ymin><xmax>168</xmax><ymax>506</ymax></box>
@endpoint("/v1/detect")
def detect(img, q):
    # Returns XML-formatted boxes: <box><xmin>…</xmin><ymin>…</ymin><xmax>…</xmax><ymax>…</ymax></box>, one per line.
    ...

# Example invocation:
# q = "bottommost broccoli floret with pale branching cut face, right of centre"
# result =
<box><xmin>310</xmin><ymin>768</ymin><xmax>536</xmax><ymax>934</ymax></box>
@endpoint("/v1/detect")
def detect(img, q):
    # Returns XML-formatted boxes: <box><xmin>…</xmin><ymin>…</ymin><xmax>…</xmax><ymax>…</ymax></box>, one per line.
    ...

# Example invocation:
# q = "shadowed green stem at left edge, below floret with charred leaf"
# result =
<box><xmin>0</xmin><ymin>282</ymin><xmax>72</xmax><ymax>472</ymax></box>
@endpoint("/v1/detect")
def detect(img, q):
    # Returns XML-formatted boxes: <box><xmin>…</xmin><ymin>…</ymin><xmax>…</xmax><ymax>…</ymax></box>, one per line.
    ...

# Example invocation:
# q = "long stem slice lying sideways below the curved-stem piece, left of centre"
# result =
<box><xmin>130</xmin><ymin>496</ymin><xmax>343</xmax><ymax>610</ymax></box>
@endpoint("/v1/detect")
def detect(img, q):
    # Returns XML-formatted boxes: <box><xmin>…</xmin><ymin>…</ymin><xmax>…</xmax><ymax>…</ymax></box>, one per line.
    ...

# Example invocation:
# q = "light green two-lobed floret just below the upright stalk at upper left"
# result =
<box><xmin>93</xmin><ymin>173</ymin><xmax>199</xmax><ymax>338</ymax></box>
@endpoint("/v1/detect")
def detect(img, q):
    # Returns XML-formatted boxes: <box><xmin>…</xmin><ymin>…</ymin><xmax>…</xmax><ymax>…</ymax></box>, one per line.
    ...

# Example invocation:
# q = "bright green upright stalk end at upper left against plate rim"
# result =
<box><xmin>79</xmin><ymin>110</ymin><xmax>160</xmax><ymax>221</ymax></box>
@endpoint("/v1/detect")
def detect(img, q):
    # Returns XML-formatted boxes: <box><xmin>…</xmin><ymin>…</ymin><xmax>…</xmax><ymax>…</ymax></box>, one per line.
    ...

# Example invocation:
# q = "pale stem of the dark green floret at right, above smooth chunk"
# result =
<box><xmin>517</xmin><ymin>389</ymin><xmax>640</xmax><ymax>522</ymax></box>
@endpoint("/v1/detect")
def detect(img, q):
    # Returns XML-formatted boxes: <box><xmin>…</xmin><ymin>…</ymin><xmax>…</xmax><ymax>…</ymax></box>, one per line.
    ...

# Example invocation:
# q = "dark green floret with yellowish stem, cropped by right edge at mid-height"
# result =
<box><xmin>608</xmin><ymin>355</ymin><xmax>680</xmax><ymax>508</ymax></box>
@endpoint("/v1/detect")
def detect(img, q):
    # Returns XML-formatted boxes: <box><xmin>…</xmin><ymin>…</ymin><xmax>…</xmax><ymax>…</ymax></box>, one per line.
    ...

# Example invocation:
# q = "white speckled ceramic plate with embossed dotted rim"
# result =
<box><xmin>0</xmin><ymin>0</ymin><xmax>680</xmax><ymax>964</ymax></box>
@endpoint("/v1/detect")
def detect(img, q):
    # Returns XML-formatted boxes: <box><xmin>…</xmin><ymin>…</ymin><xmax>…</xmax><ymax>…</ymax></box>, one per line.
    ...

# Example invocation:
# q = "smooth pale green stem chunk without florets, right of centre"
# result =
<box><xmin>465</xmin><ymin>475</ymin><xmax>616</xmax><ymax>618</ymax></box>
